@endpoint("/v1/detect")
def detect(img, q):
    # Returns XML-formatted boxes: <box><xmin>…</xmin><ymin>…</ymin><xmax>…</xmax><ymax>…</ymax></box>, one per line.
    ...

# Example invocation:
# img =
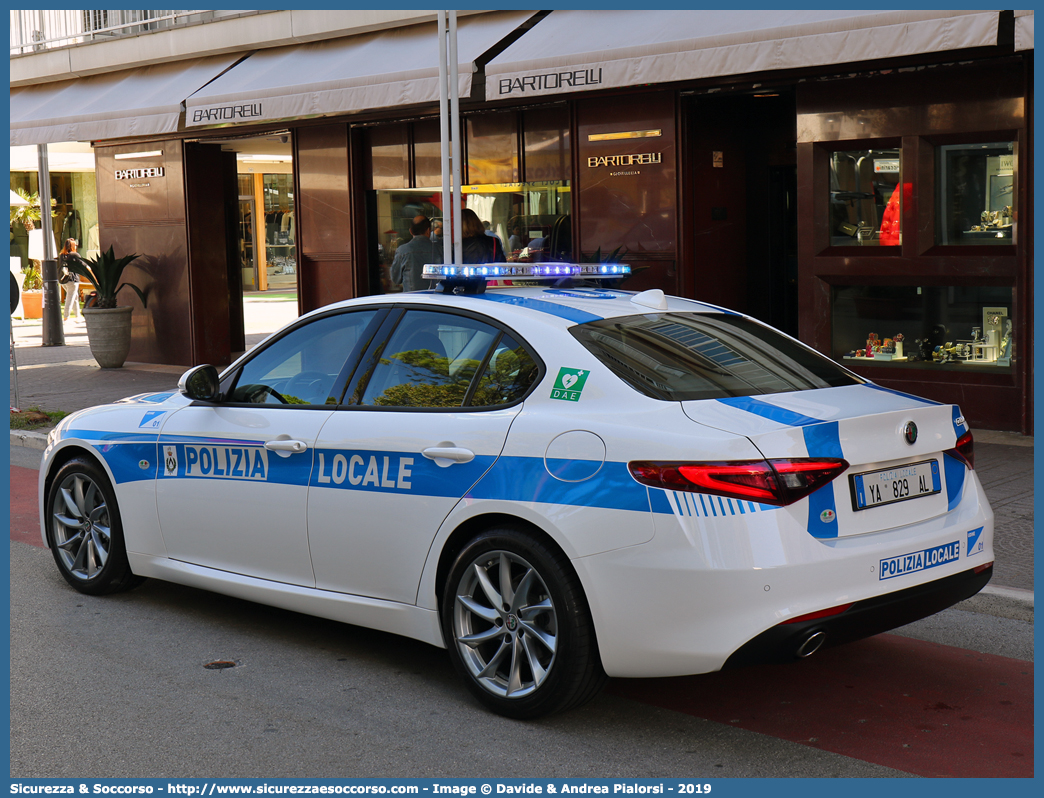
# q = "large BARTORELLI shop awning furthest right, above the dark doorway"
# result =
<box><xmin>485</xmin><ymin>8</ymin><xmax>999</xmax><ymax>100</ymax></box>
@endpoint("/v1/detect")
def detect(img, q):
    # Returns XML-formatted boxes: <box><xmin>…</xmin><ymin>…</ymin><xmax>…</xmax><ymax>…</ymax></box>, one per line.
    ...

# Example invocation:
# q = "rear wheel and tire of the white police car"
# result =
<box><xmin>442</xmin><ymin>527</ymin><xmax>607</xmax><ymax>720</ymax></box>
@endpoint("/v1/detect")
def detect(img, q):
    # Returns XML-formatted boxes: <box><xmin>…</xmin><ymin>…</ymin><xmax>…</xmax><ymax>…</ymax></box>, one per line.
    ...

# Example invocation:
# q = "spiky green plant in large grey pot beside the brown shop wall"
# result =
<box><xmin>68</xmin><ymin>247</ymin><xmax>145</xmax><ymax>369</ymax></box>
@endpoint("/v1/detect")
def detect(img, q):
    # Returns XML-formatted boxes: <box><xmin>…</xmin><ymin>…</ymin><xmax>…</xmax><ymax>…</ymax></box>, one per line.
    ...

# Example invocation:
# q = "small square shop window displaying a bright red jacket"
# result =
<box><xmin>830</xmin><ymin>148</ymin><xmax>903</xmax><ymax>247</ymax></box>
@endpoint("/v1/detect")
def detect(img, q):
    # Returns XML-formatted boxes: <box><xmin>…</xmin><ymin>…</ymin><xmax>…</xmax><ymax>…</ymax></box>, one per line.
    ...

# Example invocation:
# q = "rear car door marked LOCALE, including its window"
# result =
<box><xmin>308</xmin><ymin>308</ymin><xmax>543</xmax><ymax>604</ymax></box>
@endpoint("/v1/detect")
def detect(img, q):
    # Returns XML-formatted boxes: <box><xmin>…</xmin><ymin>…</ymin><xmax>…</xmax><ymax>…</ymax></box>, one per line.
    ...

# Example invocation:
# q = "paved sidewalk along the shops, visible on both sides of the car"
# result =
<box><xmin>10</xmin><ymin>295</ymin><xmax>1034</xmax><ymax>619</ymax></box>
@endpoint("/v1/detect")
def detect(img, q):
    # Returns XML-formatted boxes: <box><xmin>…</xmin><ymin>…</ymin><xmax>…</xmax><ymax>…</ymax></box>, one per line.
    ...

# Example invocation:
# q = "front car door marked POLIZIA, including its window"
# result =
<box><xmin>157</xmin><ymin>309</ymin><xmax>386</xmax><ymax>586</ymax></box>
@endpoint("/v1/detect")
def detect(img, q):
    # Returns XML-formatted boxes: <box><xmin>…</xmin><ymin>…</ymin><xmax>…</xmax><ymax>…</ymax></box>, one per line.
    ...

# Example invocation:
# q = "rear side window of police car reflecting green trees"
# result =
<box><xmin>359</xmin><ymin>310</ymin><xmax>537</xmax><ymax>407</ymax></box>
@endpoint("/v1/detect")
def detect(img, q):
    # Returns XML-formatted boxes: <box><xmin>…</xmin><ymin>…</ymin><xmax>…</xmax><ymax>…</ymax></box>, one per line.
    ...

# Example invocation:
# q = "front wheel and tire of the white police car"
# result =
<box><xmin>45</xmin><ymin>457</ymin><xmax>145</xmax><ymax>595</ymax></box>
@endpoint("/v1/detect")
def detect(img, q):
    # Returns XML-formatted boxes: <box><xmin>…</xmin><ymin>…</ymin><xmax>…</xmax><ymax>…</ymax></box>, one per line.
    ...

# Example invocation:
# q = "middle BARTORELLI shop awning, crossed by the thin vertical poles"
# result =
<box><xmin>185</xmin><ymin>11</ymin><xmax>533</xmax><ymax>130</ymax></box>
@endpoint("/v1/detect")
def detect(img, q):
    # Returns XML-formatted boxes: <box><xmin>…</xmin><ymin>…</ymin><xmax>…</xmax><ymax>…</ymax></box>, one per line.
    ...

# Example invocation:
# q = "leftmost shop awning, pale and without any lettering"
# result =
<box><xmin>10</xmin><ymin>55</ymin><xmax>242</xmax><ymax>146</ymax></box>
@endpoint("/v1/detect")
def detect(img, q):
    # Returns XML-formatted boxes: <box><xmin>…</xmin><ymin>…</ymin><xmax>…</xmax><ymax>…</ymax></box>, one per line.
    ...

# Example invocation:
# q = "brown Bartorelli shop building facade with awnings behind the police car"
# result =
<box><xmin>11</xmin><ymin>10</ymin><xmax>1034</xmax><ymax>433</ymax></box>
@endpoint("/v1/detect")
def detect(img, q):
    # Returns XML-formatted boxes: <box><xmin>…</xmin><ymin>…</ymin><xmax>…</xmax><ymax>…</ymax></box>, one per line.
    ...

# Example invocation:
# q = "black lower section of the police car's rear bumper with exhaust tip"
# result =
<box><xmin>721</xmin><ymin>563</ymin><xmax>993</xmax><ymax>671</ymax></box>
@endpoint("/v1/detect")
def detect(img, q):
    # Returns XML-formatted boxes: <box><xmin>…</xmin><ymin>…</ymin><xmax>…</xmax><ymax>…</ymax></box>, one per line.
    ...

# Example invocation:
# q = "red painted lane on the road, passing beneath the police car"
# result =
<box><xmin>10</xmin><ymin>466</ymin><xmax>1034</xmax><ymax>778</ymax></box>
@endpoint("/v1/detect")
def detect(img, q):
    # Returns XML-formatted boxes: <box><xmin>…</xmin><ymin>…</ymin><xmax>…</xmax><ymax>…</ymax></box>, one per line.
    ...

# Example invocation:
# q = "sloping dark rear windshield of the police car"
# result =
<box><xmin>570</xmin><ymin>313</ymin><xmax>861</xmax><ymax>401</ymax></box>
